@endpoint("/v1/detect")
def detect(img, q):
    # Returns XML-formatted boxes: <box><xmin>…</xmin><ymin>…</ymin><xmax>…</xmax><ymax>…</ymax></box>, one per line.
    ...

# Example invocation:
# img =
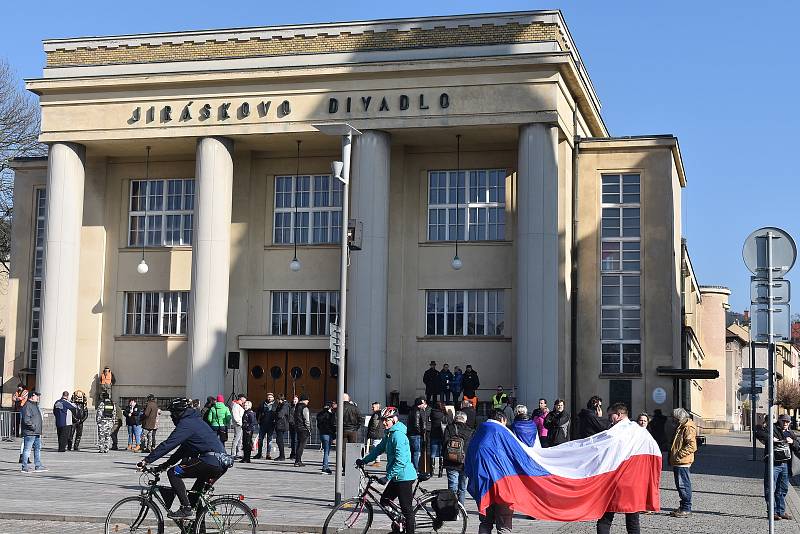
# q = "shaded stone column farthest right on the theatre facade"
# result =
<box><xmin>514</xmin><ymin>124</ymin><xmax>563</xmax><ymax>406</ymax></box>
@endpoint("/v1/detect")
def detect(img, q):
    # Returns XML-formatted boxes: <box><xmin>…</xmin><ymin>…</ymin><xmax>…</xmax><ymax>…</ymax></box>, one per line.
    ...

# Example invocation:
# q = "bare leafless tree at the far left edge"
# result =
<box><xmin>0</xmin><ymin>59</ymin><xmax>47</xmax><ymax>275</ymax></box>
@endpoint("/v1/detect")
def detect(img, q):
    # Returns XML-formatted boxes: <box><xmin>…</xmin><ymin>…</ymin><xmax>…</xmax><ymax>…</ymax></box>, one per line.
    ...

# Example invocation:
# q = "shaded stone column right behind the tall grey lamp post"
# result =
<box><xmin>347</xmin><ymin>130</ymin><xmax>391</xmax><ymax>411</ymax></box>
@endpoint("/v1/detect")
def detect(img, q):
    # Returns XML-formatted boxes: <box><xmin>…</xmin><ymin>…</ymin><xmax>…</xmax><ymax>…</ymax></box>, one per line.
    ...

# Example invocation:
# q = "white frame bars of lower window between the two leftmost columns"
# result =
<box><xmin>122</xmin><ymin>291</ymin><xmax>190</xmax><ymax>336</ymax></box>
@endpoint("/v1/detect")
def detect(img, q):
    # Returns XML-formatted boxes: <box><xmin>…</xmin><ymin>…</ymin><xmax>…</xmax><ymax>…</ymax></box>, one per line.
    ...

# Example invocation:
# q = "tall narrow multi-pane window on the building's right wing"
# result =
<box><xmin>600</xmin><ymin>174</ymin><xmax>642</xmax><ymax>374</ymax></box>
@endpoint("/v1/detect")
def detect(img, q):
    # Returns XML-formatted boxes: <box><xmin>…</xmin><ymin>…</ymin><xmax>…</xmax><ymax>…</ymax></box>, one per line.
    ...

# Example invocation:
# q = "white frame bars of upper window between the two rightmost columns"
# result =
<box><xmin>425</xmin><ymin>168</ymin><xmax>508</xmax><ymax>242</ymax></box>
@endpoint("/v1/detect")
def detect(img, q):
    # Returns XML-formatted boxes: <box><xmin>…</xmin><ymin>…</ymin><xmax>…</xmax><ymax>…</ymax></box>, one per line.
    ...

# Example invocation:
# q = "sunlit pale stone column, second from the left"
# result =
<box><xmin>186</xmin><ymin>137</ymin><xmax>233</xmax><ymax>399</ymax></box>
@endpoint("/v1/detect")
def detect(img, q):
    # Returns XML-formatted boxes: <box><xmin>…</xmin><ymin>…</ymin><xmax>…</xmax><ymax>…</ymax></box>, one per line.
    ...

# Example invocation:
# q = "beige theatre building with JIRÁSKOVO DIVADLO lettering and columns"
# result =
<box><xmin>4</xmin><ymin>11</ymin><xmax>686</xmax><ymax>411</ymax></box>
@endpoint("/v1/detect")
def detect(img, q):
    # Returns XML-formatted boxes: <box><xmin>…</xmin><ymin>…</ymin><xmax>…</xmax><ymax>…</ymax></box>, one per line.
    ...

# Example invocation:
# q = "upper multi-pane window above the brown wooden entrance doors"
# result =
<box><xmin>272</xmin><ymin>174</ymin><xmax>342</xmax><ymax>245</ymax></box>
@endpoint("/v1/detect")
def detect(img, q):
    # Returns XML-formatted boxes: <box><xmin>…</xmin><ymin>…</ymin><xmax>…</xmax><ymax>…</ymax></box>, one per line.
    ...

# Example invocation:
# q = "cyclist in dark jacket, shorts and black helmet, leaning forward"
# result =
<box><xmin>137</xmin><ymin>398</ymin><xmax>233</xmax><ymax>519</ymax></box>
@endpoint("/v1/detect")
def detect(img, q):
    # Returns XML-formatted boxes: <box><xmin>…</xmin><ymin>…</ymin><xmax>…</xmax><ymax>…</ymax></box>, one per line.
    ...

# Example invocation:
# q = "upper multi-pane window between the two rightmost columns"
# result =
<box><xmin>428</xmin><ymin>169</ymin><xmax>506</xmax><ymax>241</ymax></box>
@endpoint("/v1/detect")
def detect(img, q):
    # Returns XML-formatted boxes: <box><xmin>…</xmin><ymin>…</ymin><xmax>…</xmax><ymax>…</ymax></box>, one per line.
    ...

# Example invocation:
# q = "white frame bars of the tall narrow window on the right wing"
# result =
<box><xmin>599</xmin><ymin>172</ymin><xmax>643</xmax><ymax>375</ymax></box>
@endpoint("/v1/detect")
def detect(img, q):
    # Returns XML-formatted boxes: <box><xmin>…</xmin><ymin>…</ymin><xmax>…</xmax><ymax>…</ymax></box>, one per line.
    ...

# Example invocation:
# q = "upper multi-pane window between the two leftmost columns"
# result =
<box><xmin>128</xmin><ymin>178</ymin><xmax>194</xmax><ymax>247</ymax></box>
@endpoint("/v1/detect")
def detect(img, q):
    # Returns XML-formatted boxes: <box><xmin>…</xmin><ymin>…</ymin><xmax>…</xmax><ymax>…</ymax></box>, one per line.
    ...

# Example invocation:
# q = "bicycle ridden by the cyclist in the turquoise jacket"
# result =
<box><xmin>322</xmin><ymin>467</ymin><xmax>467</xmax><ymax>534</ymax></box>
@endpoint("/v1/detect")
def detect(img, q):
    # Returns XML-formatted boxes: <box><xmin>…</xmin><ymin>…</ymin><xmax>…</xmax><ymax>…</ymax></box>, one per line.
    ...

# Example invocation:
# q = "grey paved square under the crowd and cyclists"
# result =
<box><xmin>0</xmin><ymin>434</ymin><xmax>800</xmax><ymax>534</ymax></box>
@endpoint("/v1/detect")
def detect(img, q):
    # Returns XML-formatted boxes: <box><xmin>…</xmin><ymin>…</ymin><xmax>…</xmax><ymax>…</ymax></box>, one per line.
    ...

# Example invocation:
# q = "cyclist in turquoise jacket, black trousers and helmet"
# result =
<box><xmin>356</xmin><ymin>406</ymin><xmax>417</xmax><ymax>534</ymax></box>
